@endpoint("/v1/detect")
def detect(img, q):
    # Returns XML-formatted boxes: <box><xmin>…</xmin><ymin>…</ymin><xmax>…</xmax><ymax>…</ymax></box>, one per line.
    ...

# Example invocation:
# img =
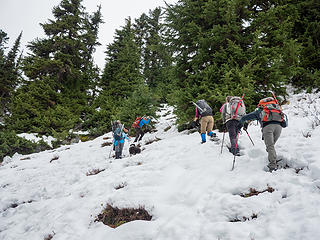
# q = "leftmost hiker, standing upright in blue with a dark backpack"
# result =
<box><xmin>112</xmin><ymin>120</ymin><xmax>129</xmax><ymax>159</ymax></box>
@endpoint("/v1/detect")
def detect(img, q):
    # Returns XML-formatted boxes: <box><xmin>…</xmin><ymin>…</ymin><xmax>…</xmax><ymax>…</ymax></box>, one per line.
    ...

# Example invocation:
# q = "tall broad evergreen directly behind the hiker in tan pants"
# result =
<box><xmin>167</xmin><ymin>0</ymin><xmax>255</xmax><ymax>123</ymax></box>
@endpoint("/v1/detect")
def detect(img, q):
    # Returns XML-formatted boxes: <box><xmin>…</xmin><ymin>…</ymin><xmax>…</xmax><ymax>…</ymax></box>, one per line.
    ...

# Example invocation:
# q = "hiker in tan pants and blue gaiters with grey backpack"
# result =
<box><xmin>192</xmin><ymin>99</ymin><xmax>217</xmax><ymax>143</ymax></box>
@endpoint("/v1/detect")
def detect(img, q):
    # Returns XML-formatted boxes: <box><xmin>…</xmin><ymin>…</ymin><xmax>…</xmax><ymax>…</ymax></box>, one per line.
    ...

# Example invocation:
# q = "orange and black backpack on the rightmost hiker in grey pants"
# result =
<box><xmin>258</xmin><ymin>97</ymin><xmax>284</xmax><ymax>122</ymax></box>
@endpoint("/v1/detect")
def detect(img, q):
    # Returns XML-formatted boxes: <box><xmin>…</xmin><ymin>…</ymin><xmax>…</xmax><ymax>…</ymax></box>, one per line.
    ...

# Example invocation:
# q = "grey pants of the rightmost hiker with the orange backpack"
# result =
<box><xmin>262</xmin><ymin>124</ymin><xmax>282</xmax><ymax>170</ymax></box>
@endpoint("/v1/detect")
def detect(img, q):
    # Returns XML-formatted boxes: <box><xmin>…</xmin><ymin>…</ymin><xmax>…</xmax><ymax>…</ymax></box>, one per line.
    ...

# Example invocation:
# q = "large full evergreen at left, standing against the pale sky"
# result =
<box><xmin>7</xmin><ymin>0</ymin><xmax>102</xmax><ymax>134</ymax></box>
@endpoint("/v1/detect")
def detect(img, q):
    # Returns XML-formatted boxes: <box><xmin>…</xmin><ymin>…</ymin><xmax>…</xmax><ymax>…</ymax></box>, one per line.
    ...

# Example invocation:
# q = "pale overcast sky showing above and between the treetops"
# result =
<box><xmin>0</xmin><ymin>0</ymin><xmax>178</xmax><ymax>69</ymax></box>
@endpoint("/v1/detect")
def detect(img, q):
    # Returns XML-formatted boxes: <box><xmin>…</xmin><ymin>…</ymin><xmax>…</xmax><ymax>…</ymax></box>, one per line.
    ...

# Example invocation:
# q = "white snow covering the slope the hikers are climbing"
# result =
<box><xmin>0</xmin><ymin>93</ymin><xmax>320</xmax><ymax>240</ymax></box>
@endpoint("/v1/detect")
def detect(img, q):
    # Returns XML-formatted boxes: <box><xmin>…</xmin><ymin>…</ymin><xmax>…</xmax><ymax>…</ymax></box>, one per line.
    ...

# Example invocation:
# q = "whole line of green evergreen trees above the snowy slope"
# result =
<box><xmin>0</xmin><ymin>0</ymin><xmax>320</xmax><ymax>161</ymax></box>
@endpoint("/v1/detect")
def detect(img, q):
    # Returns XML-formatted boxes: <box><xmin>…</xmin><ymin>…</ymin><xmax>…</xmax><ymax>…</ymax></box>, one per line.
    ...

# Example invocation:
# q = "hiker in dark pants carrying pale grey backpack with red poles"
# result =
<box><xmin>221</xmin><ymin>96</ymin><xmax>248</xmax><ymax>156</ymax></box>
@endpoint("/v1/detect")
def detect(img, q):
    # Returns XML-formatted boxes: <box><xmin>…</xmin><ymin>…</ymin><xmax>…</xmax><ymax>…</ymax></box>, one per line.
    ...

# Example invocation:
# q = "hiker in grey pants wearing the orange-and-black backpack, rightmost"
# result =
<box><xmin>238</xmin><ymin>97</ymin><xmax>287</xmax><ymax>172</ymax></box>
